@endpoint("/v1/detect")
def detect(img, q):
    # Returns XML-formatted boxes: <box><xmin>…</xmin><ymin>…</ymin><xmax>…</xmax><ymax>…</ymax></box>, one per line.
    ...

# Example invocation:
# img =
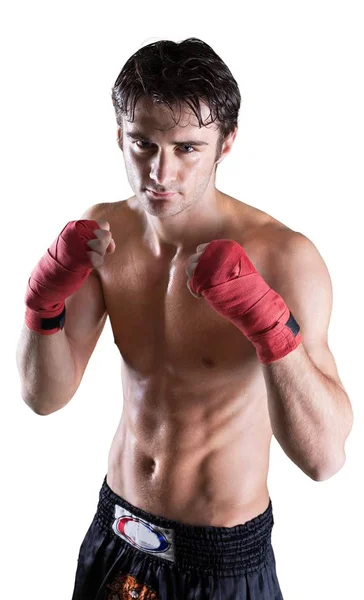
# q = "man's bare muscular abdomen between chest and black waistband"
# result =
<box><xmin>107</xmin><ymin>374</ymin><xmax>272</xmax><ymax>527</ymax></box>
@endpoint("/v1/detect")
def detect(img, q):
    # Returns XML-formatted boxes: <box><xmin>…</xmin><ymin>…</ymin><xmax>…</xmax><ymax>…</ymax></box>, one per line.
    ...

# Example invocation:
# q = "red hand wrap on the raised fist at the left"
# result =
<box><xmin>25</xmin><ymin>220</ymin><xmax>100</xmax><ymax>335</ymax></box>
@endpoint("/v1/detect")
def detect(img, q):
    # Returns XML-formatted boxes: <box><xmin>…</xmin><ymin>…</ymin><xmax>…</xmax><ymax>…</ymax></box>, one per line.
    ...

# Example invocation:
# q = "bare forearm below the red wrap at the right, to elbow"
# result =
<box><xmin>262</xmin><ymin>344</ymin><xmax>352</xmax><ymax>480</ymax></box>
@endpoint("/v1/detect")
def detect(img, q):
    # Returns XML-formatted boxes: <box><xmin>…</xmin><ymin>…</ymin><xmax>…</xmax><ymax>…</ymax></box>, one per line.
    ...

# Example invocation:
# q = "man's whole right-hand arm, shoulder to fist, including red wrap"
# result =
<box><xmin>186</xmin><ymin>230</ymin><xmax>353</xmax><ymax>480</ymax></box>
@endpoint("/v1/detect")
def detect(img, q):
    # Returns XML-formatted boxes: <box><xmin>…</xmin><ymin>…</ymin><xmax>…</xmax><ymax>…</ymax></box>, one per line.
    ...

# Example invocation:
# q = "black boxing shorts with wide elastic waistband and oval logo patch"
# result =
<box><xmin>72</xmin><ymin>476</ymin><xmax>283</xmax><ymax>600</ymax></box>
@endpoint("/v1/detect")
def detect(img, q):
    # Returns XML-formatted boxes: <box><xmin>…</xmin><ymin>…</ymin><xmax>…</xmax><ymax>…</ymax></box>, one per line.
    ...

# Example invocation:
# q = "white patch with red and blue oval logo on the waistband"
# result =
<box><xmin>112</xmin><ymin>504</ymin><xmax>175</xmax><ymax>562</ymax></box>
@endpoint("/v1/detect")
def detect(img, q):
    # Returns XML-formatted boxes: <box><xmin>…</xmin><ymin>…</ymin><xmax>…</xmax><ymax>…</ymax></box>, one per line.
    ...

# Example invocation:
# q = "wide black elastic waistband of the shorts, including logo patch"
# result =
<box><xmin>95</xmin><ymin>477</ymin><xmax>274</xmax><ymax>576</ymax></box>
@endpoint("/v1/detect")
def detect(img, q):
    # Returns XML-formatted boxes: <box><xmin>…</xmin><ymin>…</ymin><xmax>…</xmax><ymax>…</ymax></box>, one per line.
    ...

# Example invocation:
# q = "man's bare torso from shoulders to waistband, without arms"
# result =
<box><xmin>98</xmin><ymin>196</ymin><xmax>288</xmax><ymax>527</ymax></box>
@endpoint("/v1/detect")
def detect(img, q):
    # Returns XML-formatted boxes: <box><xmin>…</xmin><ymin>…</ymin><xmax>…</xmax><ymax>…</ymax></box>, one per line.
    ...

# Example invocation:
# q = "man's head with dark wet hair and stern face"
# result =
<box><xmin>112</xmin><ymin>38</ymin><xmax>241</xmax><ymax>216</ymax></box>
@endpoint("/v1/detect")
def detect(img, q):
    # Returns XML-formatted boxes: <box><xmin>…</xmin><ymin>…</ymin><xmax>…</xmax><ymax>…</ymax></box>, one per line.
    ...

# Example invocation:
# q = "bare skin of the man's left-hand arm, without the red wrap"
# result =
<box><xmin>16</xmin><ymin>205</ymin><xmax>107</xmax><ymax>415</ymax></box>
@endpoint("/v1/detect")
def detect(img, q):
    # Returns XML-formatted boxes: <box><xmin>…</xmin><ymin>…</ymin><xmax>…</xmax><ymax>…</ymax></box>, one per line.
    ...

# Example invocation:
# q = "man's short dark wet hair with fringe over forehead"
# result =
<box><xmin>111</xmin><ymin>37</ymin><xmax>241</xmax><ymax>156</ymax></box>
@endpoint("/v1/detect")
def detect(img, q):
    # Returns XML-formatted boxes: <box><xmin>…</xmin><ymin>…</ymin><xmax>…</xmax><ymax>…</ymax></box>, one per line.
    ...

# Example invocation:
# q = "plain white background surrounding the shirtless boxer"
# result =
<box><xmin>0</xmin><ymin>0</ymin><xmax>364</xmax><ymax>600</ymax></box>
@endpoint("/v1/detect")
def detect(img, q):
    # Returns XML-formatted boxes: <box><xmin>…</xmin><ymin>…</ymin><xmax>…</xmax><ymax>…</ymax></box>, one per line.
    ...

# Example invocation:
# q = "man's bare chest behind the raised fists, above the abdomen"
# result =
<box><xmin>100</xmin><ymin>220</ymin><xmax>269</xmax><ymax>381</ymax></box>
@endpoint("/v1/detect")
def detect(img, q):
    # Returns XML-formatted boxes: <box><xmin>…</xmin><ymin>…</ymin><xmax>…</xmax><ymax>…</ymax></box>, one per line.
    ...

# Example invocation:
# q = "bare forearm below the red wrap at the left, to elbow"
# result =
<box><xmin>16</xmin><ymin>324</ymin><xmax>75</xmax><ymax>415</ymax></box>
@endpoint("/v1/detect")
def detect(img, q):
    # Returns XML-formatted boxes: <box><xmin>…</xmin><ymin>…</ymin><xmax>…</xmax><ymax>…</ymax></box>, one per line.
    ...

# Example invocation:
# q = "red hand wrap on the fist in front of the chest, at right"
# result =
<box><xmin>190</xmin><ymin>240</ymin><xmax>302</xmax><ymax>364</ymax></box>
